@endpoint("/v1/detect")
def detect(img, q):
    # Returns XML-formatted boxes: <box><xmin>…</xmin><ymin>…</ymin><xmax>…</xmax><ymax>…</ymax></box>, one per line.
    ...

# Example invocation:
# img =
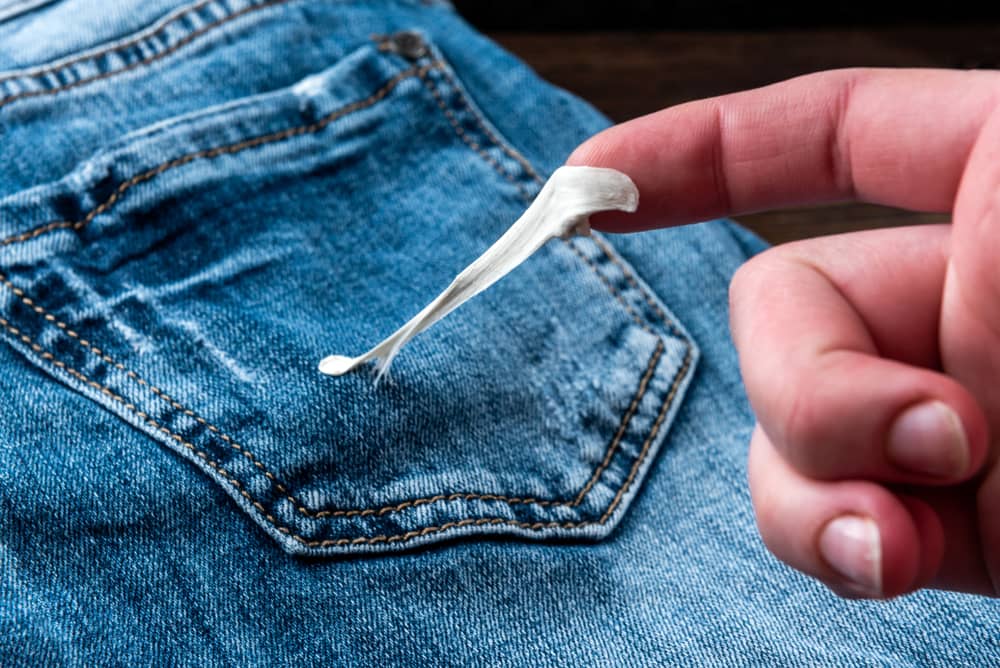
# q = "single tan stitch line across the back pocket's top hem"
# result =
<box><xmin>0</xmin><ymin>61</ymin><xmax>442</xmax><ymax>246</ymax></box>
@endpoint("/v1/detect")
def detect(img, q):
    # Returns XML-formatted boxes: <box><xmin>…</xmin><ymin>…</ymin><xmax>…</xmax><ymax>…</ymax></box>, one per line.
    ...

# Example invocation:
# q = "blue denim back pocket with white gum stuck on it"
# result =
<box><xmin>0</xmin><ymin>33</ymin><xmax>697</xmax><ymax>555</ymax></box>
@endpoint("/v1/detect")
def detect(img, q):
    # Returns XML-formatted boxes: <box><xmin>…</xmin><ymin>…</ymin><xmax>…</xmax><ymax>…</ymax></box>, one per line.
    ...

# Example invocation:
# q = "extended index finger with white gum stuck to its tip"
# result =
<box><xmin>567</xmin><ymin>69</ymin><xmax>1000</xmax><ymax>231</ymax></box>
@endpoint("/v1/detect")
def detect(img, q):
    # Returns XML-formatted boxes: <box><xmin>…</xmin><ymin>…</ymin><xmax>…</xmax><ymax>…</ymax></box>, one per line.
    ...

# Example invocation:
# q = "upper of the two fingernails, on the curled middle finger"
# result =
<box><xmin>886</xmin><ymin>401</ymin><xmax>969</xmax><ymax>478</ymax></box>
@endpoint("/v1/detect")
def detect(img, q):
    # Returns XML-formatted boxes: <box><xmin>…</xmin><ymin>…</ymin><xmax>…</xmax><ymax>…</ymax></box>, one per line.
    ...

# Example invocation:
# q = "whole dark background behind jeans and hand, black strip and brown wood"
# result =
<box><xmin>454</xmin><ymin>0</ymin><xmax>1000</xmax><ymax>243</ymax></box>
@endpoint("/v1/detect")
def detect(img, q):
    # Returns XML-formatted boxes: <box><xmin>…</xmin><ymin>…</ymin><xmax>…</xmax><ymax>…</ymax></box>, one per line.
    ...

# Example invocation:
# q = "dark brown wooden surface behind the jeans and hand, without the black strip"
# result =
<box><xmin>490</xmin><ymin>24</ymin><xmax>1000</xmax><ymax>243</ymax></box>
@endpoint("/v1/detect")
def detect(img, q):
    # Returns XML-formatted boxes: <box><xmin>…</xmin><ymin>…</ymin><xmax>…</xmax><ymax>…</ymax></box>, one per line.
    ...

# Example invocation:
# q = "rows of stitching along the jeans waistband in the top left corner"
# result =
<box><xmin>0</xmin><ymin>0</ymin><xmax>290</xmax><ymax>108</ymax></box>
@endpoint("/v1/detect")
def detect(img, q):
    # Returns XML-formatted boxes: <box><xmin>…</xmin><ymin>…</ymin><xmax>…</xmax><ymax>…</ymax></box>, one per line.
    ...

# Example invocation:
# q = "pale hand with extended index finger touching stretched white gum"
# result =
<box><xmin>569</xmin><ymin>69</ymin><xmax>1000</xmax><ymax>598</ymax></box>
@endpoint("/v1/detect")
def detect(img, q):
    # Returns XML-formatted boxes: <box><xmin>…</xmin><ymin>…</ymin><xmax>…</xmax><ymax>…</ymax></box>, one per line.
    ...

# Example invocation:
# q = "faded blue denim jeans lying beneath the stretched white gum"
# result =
<box><xmin>0</xmin><ymin>0</ymin><xmax>1000</xmax><ymax>666</ymax></box>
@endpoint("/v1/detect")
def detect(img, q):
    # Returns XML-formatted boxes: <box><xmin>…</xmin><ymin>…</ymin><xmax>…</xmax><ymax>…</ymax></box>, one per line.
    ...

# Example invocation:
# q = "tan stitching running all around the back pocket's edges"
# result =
<box><xmin>0</xmin><ymin>48</ymin><xmax>693</xmax><ymax>547</ymax></box>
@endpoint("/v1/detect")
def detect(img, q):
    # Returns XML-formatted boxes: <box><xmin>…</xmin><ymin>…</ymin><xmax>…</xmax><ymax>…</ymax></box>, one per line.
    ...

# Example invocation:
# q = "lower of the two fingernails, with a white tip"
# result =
<box><xmin>819</xmin><ymin>515</ymin><xmax>882</xmax><ymax>598</ymax></box>
